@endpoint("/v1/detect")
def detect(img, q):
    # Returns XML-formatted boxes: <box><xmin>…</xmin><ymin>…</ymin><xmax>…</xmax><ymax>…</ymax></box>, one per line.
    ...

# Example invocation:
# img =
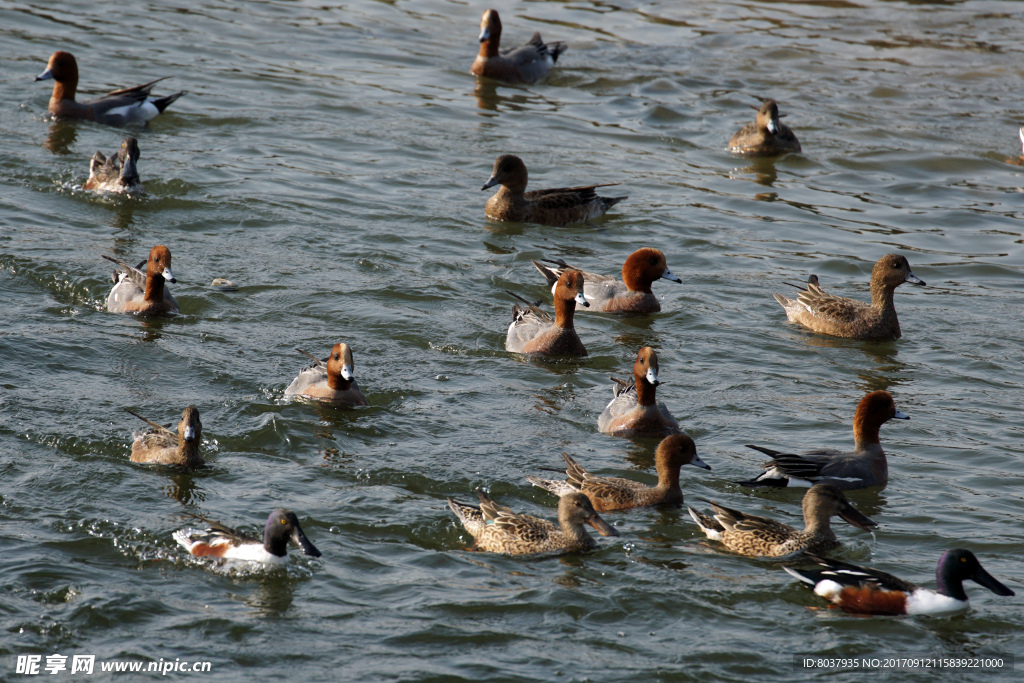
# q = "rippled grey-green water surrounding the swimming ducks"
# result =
<box><xmin>0</xmin><ymin>0</ymin><xmax>1024</xmax><ymax>681</ymax></box>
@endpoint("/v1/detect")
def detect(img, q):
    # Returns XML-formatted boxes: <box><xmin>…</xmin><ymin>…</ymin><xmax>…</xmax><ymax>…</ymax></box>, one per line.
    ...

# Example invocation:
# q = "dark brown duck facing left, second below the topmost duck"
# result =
<box><xmin>480</xmin><ymin>155</ymin><xmax>628</xmax><ymax>226</ymax></box>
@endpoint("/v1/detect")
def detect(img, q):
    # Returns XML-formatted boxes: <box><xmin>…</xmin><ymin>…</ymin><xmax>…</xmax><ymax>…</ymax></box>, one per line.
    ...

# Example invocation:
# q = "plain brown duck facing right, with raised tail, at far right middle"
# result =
<box><xmin>772</xmin><ymin>254</ymin><xmax>925</xmax><ymax>341</ymax></box>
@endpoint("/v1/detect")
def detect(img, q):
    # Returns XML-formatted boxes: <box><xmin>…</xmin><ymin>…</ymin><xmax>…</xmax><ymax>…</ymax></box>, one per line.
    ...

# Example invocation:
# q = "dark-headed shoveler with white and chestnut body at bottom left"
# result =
<box><xmin>173</xmin><ymin>508</ymin><xmax>322</xmax><ymax>564</ymax></box>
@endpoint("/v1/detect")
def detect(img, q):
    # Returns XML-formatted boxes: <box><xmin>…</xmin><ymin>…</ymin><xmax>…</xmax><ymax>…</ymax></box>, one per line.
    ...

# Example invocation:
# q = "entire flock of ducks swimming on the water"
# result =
<box><xmin>36</xmin><ymin>9</ymin><xmax>1024</xmax><ymax>614</ymax></box>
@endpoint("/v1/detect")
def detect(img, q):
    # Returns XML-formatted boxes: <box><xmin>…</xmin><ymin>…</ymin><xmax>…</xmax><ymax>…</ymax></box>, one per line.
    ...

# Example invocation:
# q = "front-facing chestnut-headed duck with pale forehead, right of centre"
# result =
<box><xmin>597</xmin><ymin>346</ymin><xmax>680</xmax><ymax>436</ymax></box>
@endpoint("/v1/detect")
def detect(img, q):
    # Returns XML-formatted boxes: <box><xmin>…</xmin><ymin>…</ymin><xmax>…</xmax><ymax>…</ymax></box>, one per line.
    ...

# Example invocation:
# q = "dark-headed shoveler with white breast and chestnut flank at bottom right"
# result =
<box><xmin>782</xmin><ymin>548</ymin><xmax>1016</xmax><ymax>615</ymax></box>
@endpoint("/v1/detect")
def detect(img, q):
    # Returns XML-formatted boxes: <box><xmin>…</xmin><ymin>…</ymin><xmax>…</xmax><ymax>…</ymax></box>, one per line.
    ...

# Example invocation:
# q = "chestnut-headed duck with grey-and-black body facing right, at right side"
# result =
<box><xmin>737</xmin><ymin>391</ymin><xmax>910</xmax><ymax>488</ymax></box>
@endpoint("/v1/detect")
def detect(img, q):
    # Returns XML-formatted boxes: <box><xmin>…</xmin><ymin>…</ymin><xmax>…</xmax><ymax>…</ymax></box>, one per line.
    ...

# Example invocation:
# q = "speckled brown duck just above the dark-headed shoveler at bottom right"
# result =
<box><xmin>686</xmin><ymin>483</ymin><xmax>878</xmax><ymax>559</ymax></box>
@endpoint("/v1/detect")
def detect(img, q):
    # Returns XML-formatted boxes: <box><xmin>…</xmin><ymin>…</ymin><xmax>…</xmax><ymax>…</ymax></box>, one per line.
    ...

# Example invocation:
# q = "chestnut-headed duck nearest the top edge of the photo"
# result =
<box><xmin>469</xmin><ymin>9</ymin><xmax>565</xmax><ymax>84</ymax></box>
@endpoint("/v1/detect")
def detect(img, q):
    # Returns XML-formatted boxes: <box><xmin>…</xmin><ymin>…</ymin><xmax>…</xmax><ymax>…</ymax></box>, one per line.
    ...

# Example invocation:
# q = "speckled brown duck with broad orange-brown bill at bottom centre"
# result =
<box><xmin>449</xmin><ymin>490</ymin><xmax>618</xmax><ymax>555</ymax></box>
